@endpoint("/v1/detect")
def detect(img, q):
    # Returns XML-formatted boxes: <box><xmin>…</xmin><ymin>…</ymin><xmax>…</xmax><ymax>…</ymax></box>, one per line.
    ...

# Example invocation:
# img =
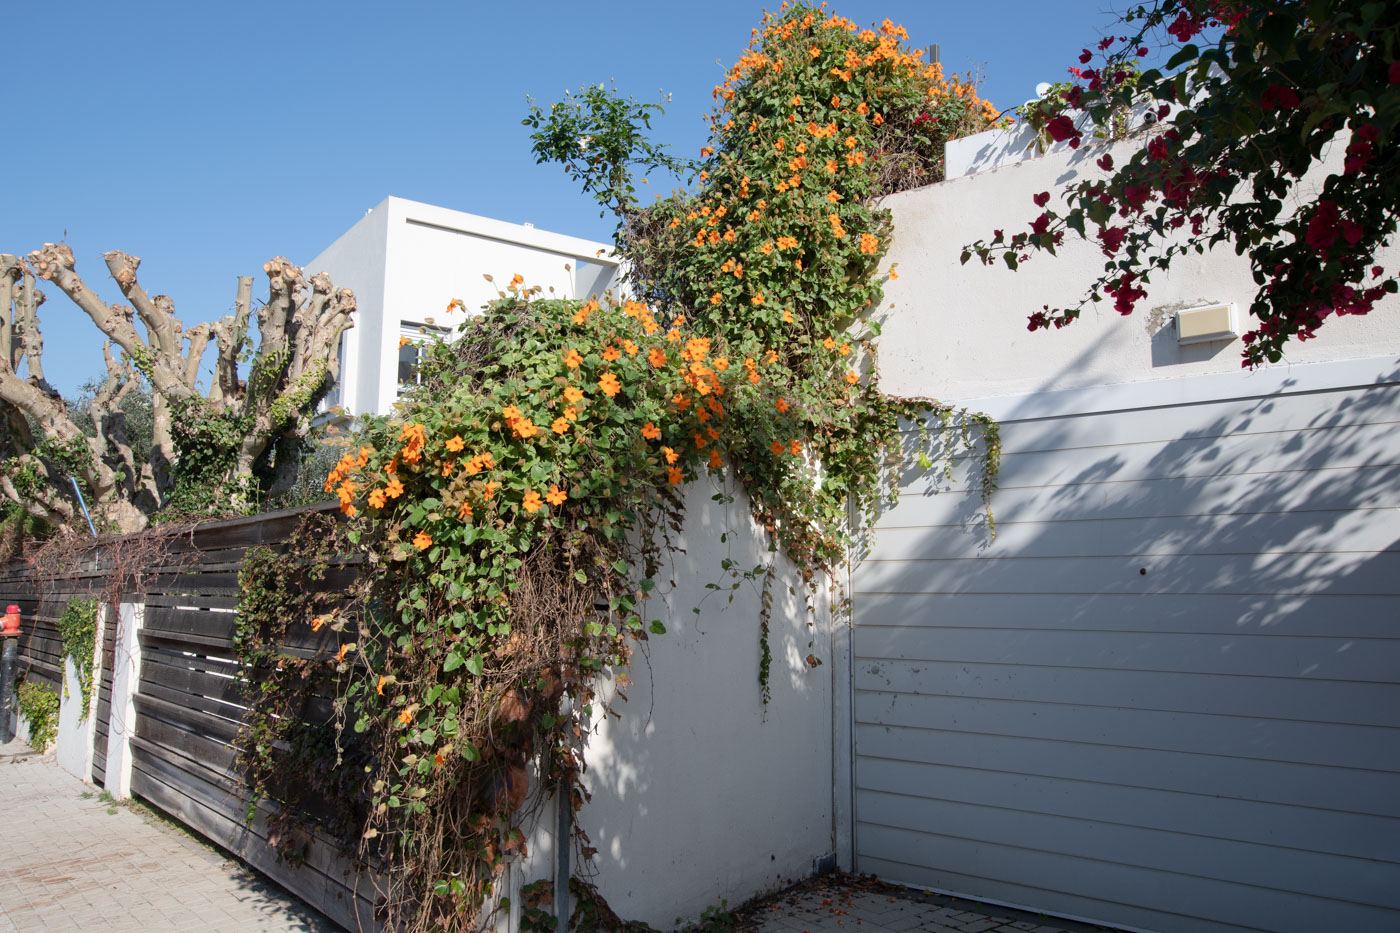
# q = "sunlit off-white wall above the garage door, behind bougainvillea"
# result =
<box><xmin>881</xmin><ymin>124</ymin><xmax>1400</xmax><ymax>401</ymax></box>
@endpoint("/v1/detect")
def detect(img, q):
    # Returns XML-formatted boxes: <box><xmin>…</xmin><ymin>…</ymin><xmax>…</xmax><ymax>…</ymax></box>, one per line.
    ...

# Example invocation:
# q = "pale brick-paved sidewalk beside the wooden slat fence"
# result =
<box><xmin>0</xmin><ymin>741</ymin><xmax>339</xmax><ymax>933</ymax></box>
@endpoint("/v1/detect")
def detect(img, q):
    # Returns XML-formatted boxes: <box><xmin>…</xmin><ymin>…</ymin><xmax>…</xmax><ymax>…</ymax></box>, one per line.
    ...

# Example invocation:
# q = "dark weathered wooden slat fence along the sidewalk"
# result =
<box><xmin>0</xmin><ymin>507</ymin><xmax>378</xmax><ymax>930</ymax></box>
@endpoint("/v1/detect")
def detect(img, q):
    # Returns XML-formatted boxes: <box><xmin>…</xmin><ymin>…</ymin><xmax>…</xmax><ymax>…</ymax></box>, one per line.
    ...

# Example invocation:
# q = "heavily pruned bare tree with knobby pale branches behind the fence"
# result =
<box><xmin>0</xmin><ymin>244</ymin><xmax>354</xmax><ymax>531</ymax></box>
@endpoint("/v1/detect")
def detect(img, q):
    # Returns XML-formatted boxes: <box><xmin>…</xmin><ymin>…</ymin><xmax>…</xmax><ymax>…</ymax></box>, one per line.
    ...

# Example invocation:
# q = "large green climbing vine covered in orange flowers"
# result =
<box><xmin>238</xmin><ymin>4</ymin><xmax>998</xmax><ymax>930</ymax></box>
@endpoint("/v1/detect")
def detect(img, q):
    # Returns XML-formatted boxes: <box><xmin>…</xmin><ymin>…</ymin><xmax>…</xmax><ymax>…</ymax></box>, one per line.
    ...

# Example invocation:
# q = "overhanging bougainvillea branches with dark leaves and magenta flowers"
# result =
<box><xmin>963</xmin><ymin>0</ymin><xmax>1400</xmax><ymax>366</ymax></box>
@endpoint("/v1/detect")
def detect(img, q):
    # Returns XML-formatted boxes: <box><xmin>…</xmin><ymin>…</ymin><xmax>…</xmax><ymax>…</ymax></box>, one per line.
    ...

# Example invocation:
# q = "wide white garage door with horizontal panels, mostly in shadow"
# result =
<box><xmin>853</xmin><ymin>363</ymin><xmax>1400</xmax><ymax>932</ymax></box>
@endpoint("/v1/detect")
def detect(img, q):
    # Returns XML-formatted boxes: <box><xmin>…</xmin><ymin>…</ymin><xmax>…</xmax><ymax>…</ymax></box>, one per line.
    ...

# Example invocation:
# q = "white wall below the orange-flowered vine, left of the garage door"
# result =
<box><xmin>497</xmin><ymin>481</ymin><xmax>834</xmax><ymax>933</ymax></box>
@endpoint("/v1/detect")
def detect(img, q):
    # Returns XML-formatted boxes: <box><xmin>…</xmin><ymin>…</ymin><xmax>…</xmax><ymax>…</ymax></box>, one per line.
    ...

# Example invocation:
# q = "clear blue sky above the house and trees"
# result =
<box><xmin>0</xmin><ymin>0</ymin><xmax>1126</xmax><ymax>396</ymax></box>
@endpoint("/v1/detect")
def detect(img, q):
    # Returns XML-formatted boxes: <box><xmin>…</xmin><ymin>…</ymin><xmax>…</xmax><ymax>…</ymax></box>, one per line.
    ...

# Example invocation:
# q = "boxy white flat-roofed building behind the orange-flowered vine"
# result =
<box><xmin>305</xmin><ymin>198</ymin><xmax>617</xmax><ymax>415</ymax></box>
